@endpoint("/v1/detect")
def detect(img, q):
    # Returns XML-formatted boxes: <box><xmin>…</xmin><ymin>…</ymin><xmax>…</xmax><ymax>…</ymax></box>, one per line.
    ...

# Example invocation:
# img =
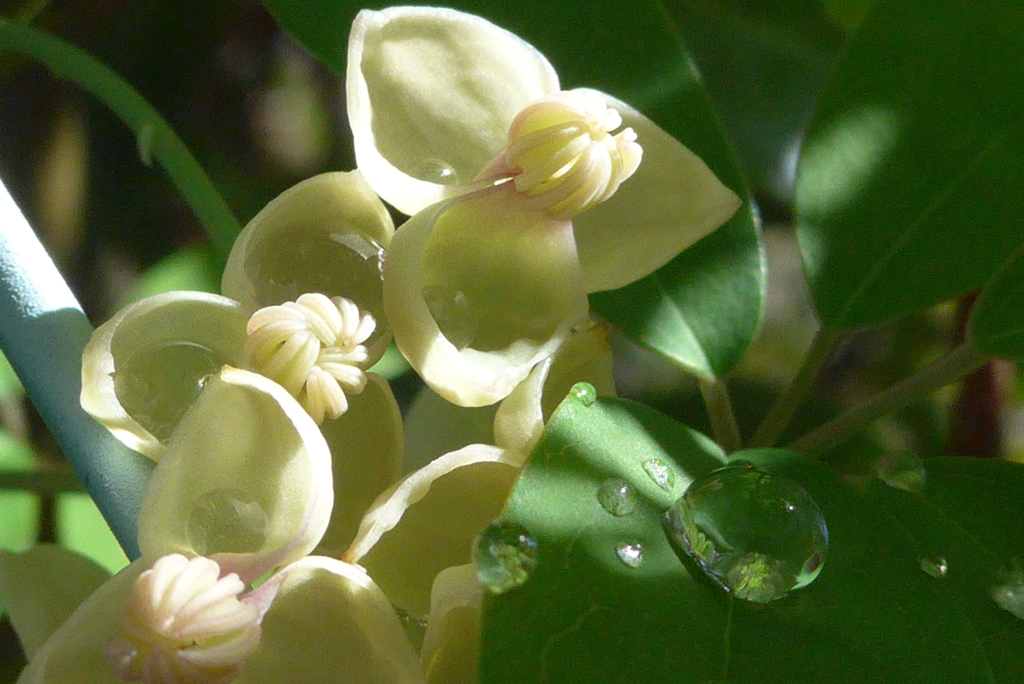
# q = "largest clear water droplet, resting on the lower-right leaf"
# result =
<box><xmin>666</xmin><ymin>466</ymin><xmax>828</xmax><ymax>603</ymax></box>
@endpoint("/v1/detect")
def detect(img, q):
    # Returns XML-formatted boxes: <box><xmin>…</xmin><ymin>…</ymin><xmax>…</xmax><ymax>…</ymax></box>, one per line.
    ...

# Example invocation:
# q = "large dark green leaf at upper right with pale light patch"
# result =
<box><xmin>796</xmin><ymin>0</ymin><xmax>1024</xmax><ymax>330</ymax></box>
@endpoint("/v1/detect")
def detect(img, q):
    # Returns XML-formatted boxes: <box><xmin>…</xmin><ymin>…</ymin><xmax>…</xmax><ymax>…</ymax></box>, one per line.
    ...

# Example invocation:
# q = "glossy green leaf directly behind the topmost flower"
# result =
<box><xmin>264</xmin><ymin>0</ymin><xmax>765</xmax><ymax>376</ymax></box>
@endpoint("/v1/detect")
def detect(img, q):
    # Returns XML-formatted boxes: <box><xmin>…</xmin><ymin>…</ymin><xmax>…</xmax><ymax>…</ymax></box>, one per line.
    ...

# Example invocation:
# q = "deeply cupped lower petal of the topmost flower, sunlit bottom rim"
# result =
<box><xmin>384</xmin><ymin>183</ymin><xmax>588</xmax><ymax>407</ymax></box>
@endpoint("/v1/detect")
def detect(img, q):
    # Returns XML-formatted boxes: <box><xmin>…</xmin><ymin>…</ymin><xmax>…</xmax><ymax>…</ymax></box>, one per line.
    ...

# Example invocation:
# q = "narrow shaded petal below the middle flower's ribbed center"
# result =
<box><xmin>316</xmin><ymin>373</ymin><xmax>404</xmax><ymax>556</ymax></box>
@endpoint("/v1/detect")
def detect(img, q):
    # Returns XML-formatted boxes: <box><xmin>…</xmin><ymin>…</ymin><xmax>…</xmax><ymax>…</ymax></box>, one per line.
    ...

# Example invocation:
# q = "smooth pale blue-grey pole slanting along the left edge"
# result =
<box><xmin>0</xmin><ymin>175</ymin><xmax>153</xmax><ymax>558</ymax></box>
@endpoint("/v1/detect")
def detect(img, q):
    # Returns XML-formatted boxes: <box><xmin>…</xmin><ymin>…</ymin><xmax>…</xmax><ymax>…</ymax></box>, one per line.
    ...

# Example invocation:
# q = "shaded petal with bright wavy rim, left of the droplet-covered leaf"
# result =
<box><xmin>343</xmin><ymin>444</ymin><xmax>518</xmax><ymax>615</ymax></box>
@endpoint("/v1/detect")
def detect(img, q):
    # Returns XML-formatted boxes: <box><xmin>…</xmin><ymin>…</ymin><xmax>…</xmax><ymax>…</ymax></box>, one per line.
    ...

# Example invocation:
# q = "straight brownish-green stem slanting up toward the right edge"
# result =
<box><xmin>788</xmin><ymin>342</ymin><xmax>988</xmax><ymax>454</ymax></box>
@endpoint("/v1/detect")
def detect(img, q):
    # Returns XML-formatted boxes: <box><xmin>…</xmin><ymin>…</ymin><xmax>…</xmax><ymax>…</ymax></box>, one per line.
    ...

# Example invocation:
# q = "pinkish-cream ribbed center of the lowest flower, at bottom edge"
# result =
<box><xmin>103</xmin><ymin>554</ymin><xmax>260</xmax><ymax>684</ymax></box>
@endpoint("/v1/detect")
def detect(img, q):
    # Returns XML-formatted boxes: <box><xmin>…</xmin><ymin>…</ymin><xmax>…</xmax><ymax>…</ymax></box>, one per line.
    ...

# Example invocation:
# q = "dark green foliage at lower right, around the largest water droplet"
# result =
<box><xmin>480</xmin><ymin>398</ymin><xmax>1024</xmax><ymax>684</ymax></box>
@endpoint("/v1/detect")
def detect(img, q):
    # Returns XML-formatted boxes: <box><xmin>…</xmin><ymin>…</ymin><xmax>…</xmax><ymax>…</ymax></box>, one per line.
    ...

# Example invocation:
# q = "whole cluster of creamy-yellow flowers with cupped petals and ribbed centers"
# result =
<box><xmin>9</xmin><ymin>7</ymin><xmax>739</xmax><ymax>684</ymax></box>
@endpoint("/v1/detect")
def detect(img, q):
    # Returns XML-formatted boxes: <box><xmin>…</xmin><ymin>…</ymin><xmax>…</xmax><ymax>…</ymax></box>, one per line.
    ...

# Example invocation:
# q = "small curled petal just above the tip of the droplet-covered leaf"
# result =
<box><xmin>495</xmin><ymin>324</ymin><xmax>615</xmax><ymax>465</ymax></box>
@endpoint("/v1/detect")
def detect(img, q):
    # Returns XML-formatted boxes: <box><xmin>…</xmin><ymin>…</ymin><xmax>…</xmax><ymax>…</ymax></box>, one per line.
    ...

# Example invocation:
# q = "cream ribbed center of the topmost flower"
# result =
<box><xmin>505</xmin><ymin>91</ymin><xmax>643</xmax><ymax>219</ymax></box>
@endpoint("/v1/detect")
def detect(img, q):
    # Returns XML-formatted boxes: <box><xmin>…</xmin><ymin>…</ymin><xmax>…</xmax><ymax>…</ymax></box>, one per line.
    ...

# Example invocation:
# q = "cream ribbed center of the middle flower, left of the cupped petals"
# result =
<box><xmin>244</xmin><ymin>293</ymin><xmax>377</xmax><ymax>425</ymax></box>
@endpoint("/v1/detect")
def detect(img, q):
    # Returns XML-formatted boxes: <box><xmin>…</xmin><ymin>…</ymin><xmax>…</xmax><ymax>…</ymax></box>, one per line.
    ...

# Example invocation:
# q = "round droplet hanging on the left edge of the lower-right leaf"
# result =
<box><xmin>473</xmin><ymin>521</ymin><xmax>540</xmax><ymax>594</ymax></box>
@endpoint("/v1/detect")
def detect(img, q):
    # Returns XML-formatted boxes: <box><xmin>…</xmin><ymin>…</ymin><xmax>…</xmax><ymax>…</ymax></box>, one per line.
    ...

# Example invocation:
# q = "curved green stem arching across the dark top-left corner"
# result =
<box><xmin>0</xmin><ymin>18</ymin><xmax>242</xmax><ymax>257</ymax></box>
